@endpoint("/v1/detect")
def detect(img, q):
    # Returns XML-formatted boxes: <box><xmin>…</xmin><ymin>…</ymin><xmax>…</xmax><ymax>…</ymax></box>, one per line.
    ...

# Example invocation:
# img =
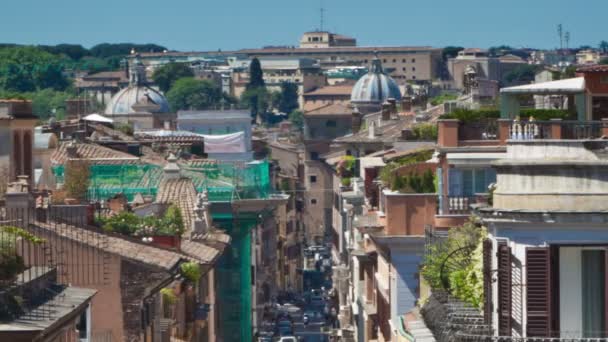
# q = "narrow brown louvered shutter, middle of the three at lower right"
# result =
<box><xmin>497</xmin><ymin>244</ymin><xmax>512</xmax><ymax>336</ymax></box>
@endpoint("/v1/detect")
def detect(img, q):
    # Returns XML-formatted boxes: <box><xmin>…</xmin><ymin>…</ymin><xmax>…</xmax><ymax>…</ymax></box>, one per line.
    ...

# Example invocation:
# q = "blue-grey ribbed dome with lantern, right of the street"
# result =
<box><xmin>350</xmin><ymin>57</ymin><xmax>401</xmax><ymax>105</ymax></box>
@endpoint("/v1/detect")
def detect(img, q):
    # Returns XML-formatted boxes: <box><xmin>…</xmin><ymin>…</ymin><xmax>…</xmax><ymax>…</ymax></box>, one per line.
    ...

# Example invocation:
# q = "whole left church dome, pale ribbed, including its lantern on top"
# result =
<box><xmin>105</xmin><ymin>59</ymin><xmax>169</xmax><ymax>116</ymax></box>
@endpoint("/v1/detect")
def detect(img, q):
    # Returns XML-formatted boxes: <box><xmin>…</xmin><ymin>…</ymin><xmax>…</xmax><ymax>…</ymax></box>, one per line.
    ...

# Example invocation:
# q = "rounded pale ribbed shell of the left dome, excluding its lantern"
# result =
<box><xmin>105</xmin><ymin>85</ymin><xmax>169</xmax><ymax>116</ymax></box>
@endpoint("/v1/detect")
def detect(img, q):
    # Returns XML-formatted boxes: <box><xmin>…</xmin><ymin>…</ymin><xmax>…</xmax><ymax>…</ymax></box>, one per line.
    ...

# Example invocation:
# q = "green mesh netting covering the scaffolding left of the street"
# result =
<box><xmin>53</xmin><ymin>161</ymin><xmax>272</xmax><ymax>341</ymax></box>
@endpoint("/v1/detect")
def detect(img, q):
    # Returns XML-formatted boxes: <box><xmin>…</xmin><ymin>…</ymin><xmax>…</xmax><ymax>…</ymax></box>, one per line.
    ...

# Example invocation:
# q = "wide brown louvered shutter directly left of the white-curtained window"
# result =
<box><xmin>526</xmin><ymin>247</ymin><xmax>552</xmax><ymax>337</ymax></box>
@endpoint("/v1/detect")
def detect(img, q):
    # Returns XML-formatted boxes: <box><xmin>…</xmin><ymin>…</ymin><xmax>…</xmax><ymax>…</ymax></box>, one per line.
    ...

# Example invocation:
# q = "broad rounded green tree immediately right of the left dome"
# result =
<box><xmin>167</xmin><ymin>77</ymin><xmax>222</xmax><ymax>112</ymax></box>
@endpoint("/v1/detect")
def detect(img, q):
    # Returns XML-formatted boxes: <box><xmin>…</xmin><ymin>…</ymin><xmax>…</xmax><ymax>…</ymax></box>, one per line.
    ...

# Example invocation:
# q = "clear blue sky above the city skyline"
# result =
<box><xmin>0</xmin><ymin>0</ymin><xmax>608</xmax><ymax>51</ymax></box>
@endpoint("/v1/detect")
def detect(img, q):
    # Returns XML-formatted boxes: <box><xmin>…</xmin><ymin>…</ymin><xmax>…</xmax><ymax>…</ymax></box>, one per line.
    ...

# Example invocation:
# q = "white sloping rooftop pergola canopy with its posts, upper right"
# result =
<box><xmin>500</xmin><ymin>77</ymin><xmax>587</xmax><ymax>121</ymax></box>
